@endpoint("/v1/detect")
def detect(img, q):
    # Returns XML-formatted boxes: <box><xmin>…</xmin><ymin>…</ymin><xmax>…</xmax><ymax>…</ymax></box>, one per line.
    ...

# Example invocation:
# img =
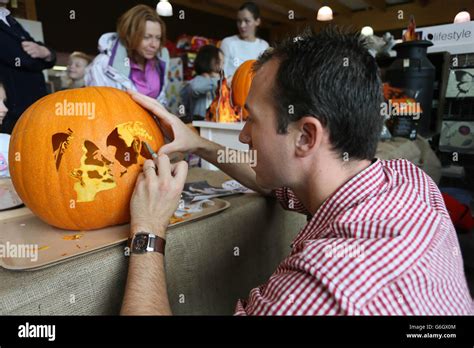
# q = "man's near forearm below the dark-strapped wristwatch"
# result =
<box><xmin>120</xmin><ymin>253</ymin><xmax>172</xmax><ymax>315</ymax></box>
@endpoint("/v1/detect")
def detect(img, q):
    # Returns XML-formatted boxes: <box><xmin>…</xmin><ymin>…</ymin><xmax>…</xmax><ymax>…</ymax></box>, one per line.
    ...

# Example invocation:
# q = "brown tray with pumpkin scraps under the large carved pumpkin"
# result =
<box><xmin>0</xmin><ymin>198</ymin><xmax>230</xmax><ymax>270</ymax></box>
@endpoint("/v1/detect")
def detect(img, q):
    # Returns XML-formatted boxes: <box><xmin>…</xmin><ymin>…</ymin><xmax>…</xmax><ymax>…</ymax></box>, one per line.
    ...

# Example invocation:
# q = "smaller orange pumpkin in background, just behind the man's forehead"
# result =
<box><xmin>232</xmin><ymin>59</ymin><xmax>256</xmax><ymax>120</ymax></box>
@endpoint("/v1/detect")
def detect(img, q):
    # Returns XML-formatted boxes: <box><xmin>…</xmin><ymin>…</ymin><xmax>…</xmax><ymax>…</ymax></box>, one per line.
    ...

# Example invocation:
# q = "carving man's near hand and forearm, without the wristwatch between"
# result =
<box><xmin>121</xmin><ymin>155</ymin><xmax>184</xmax><ymax>315</ymax></box>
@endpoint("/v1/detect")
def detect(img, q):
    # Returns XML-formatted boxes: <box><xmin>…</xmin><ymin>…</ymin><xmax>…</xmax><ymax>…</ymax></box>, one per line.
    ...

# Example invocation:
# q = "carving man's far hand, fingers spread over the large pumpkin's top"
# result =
<box><xmin>128</xmin><ymin>91</ymin><xmax>202</xmax><ymax>155</ymax></box>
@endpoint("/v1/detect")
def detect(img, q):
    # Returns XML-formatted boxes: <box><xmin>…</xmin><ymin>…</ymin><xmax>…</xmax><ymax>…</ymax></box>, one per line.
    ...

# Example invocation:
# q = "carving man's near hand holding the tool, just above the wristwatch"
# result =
<box><xmin>130</xmin><ymin>155</ymin><xmax>188</xmax><ymax>239</ymax></box>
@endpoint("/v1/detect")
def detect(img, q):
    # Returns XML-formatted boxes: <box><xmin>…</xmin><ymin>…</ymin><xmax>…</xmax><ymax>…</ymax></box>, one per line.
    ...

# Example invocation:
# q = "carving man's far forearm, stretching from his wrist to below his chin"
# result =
<box><xmin>194</xmin><ymin>138</ymin><xmax>271</xmax><ymax>195</ymax></box>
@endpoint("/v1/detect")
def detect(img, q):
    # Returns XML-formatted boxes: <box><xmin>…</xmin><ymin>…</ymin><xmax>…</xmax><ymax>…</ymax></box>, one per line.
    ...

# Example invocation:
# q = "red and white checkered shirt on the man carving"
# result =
<box><xmin>235</xmin><ymin>160</ymin><xmax>473</xmax><ymax>315</ymax></box>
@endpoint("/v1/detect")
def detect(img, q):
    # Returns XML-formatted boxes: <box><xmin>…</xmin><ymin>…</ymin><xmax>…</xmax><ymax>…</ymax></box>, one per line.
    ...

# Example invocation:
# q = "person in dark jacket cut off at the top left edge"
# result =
<box><xmin>0</xmin><ymin>0</ymin><xmax>56</xmax><ymax>134</ymax></box>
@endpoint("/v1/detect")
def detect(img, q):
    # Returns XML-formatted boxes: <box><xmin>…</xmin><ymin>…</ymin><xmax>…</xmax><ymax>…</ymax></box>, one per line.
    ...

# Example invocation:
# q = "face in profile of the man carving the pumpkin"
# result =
<box><xmin>239</xmin><ymin>59</ymin><xmax>296</xmax><ymax>189</ymax></box>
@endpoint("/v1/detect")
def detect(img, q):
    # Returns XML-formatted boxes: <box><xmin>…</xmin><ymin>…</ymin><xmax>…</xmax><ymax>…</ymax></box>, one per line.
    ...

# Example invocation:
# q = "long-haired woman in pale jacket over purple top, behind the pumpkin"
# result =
<box><xmin>85</xmin><ymin>5</ymin><xmax>169</xmax><ymax>105</ymax></box>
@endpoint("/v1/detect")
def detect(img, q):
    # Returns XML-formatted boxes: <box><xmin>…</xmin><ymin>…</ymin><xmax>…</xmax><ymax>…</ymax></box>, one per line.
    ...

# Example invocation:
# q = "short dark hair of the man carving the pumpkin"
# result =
<box><xmin>254</xmin><ymin>27</ymin><xmax>383</xmax><ymax>160</ymax></box>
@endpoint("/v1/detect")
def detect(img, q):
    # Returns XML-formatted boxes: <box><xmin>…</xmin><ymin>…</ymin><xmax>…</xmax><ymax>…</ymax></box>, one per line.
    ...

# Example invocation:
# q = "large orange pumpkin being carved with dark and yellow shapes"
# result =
<box><xmin>9</xmin><ymin>87</ymin><xmax>164</xmax><ymax>230</ymax></box>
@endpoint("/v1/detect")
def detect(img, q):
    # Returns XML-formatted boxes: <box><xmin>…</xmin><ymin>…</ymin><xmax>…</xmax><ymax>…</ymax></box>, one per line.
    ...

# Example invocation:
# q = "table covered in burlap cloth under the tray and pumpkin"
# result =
<box><xmin>0</xmin><ymin>169</ymin><xmax>305</xmax><ymax>315</ymax></box>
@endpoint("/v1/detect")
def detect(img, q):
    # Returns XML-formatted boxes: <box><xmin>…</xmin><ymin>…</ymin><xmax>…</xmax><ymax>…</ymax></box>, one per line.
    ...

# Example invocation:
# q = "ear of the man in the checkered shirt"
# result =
<box><xmin>295</xmin><ymin>116</ymin><xmax>323</xmax><ymax>157</ymax></box>
